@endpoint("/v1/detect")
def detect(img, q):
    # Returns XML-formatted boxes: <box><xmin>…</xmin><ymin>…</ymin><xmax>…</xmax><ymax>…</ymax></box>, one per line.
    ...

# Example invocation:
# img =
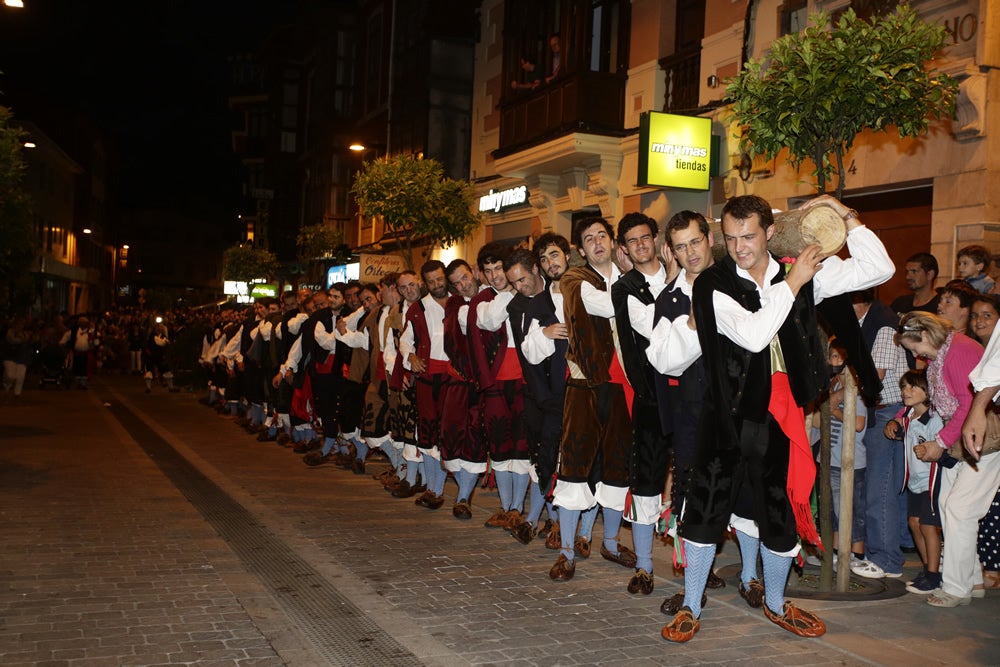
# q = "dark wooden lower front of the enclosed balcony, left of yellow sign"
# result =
<box><xmin>495</xmin><ymin>72</ymin><xmax>626</xmax><ymax>157</ymax></box>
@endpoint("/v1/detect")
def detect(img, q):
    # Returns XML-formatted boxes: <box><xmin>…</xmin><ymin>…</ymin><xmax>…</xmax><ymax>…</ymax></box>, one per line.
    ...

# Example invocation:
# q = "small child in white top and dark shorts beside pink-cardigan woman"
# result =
<box><xmin>885</xmin><ymin>370</ymin><xmax>954</xmax><ymax>595</ymax></box>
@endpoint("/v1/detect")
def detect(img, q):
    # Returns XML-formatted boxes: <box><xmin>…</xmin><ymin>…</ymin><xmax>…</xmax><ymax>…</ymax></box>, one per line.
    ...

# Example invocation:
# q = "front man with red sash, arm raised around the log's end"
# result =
<box><xmin>661</xmin><ymin>195</ymin><xmax>894</xmax><ymax>642</ymax></box>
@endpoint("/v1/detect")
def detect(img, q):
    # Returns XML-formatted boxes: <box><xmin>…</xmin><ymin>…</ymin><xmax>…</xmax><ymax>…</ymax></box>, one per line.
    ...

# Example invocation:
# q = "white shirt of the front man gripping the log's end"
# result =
<box><xmin>712</xmin><ymin>225</ymin><xmax>896</xmax><ymax>352</ymax></box>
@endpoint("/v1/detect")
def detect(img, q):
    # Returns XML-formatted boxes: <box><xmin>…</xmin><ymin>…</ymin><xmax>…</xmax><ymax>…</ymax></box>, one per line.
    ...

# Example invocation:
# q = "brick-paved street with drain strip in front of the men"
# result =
<box><xmin>0</xmin><ymin>376</ymin><xmax>1000</xmax><ymax>667</ymax></box>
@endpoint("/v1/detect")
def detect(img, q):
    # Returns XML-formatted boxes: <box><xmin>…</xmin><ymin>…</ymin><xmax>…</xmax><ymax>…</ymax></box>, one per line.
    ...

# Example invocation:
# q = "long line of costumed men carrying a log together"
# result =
<box><xmin>203</xmin><ymin>190</ymin><xmax>894</xmax><ymax>642</ymax></box>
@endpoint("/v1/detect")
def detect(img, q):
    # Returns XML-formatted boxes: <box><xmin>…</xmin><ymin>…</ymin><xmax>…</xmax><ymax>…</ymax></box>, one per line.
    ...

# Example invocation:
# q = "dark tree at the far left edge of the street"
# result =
<box><xmin>0</xmin><ymin>106</ymin><xmax>38</xmax><ymax>309</ymax></box>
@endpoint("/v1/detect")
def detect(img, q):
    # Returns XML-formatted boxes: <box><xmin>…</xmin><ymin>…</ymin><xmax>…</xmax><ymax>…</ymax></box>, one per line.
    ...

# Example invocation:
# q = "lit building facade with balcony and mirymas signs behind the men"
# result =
<box><xmin>467</xmin><ymin>0</ymin><xmax>1000</xmax><ymax>297</ymax></box>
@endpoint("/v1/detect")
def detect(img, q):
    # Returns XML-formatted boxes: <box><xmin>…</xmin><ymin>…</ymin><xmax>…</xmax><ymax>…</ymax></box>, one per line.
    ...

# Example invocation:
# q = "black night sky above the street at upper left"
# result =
<box><xmin>0</xmin><ymin>0</ymin><xmax>293</xmax><ymax>214</ymax></box>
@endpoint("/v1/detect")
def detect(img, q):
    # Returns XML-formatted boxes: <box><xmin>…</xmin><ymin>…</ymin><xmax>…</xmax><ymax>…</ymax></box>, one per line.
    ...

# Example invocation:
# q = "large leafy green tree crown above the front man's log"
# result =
<box><xmin>726</xmin><ymin>5</ymin><xmax>958</xmax><ymax>197</ymax></box>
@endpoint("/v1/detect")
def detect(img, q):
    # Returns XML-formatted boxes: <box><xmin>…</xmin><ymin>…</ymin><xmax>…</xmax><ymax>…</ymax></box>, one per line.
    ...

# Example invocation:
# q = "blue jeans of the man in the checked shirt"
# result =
<box><xmin>865</xmin><ymin>403</ymin><xmax>906</xmax><ymax>573</ymax></box>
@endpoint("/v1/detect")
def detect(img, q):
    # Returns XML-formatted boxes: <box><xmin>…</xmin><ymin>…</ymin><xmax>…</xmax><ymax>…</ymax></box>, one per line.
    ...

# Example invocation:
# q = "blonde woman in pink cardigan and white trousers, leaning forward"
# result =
<box><xmin>896</xmin><ymin>310</ymin><xmax>996</xmax><ymax>607</ymax></box>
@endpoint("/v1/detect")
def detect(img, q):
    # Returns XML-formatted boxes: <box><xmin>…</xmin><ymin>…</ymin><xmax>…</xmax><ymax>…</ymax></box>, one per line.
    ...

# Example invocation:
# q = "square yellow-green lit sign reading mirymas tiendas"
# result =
<box><xmin>637</xmin><ymin>111</ymin><xmax>714</xmax><ymax>190</ymax></box>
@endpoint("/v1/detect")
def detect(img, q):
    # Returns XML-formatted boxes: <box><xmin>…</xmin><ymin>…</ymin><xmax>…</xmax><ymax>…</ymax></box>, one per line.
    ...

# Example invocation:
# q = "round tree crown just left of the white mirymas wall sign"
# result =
<box><xmin>351</xmin><ymin>155</ymin><xmax>480</xmax><ymax>265</ymax></box>
